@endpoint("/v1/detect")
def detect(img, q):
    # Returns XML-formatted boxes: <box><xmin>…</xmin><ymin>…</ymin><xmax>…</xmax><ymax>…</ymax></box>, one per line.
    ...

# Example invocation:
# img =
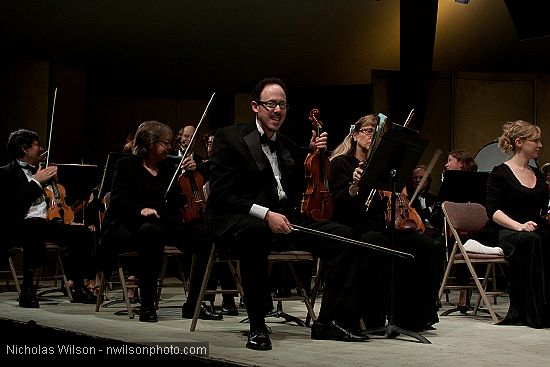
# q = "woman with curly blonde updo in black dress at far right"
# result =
<box><xmin>486</xmin><ymin>120</ymin><xmax>550</xmax><ymax>328</ymax></box>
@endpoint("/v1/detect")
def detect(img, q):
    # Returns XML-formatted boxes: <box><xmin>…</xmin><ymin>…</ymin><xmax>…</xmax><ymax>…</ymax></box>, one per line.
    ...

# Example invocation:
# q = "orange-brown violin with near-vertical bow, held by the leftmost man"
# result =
<box><xmin>44</xmin><ymin>88</ymin><xmax>74</xmax><ymax>224</ymax></box>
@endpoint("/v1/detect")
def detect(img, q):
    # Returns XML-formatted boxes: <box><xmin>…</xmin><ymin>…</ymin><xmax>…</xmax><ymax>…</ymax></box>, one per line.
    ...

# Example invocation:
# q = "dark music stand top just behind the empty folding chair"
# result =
<box><xmin>439</xmin><ymin>170</ymin><xmax>489</xmax><ymax>205</ymax></box>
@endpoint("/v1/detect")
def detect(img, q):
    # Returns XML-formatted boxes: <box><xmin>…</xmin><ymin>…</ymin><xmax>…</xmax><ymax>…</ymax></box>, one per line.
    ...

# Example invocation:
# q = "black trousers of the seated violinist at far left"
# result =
<box><xmin>15</xmin><ymin>218</ymin><xmax>97</xmax><ymax>286</ymax></box>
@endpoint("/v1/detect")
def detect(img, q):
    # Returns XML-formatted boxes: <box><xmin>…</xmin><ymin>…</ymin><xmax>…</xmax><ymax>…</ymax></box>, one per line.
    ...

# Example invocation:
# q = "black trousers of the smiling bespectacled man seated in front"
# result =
<box><xmin>227</xmin><ymin>216</ymin><xmax>359</xmax><ymax>328</ymax></box>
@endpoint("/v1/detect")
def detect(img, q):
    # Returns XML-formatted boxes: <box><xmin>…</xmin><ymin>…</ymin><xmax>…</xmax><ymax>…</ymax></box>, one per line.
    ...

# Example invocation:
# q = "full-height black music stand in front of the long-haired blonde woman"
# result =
<box><xmin>358</xmin><ymin>122</ymin><xmax>431</xmax><ymax>344</ymax></box>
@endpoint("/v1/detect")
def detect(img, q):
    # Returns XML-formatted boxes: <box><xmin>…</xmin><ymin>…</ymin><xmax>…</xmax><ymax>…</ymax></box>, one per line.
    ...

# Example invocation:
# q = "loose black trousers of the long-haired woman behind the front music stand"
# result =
<box><xmin>360</xmin><ymin>230</ymin><xmax>442</xmax><ymax>331</ymax></box>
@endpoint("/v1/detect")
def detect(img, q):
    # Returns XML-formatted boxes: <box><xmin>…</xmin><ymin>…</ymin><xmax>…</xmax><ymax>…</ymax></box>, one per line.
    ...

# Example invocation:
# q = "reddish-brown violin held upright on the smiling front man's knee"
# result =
<box><xmin>301</xmin><ymin>108</ymin><xmax>333</xmax><ymax>222</ymax></box>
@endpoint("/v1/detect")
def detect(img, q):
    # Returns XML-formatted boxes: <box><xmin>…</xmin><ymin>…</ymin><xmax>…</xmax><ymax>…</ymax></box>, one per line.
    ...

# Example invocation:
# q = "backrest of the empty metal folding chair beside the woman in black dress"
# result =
<box><xmin>441</xmin><ymin>201</ymin><xmax>489</xmax><ymax>232</ymax></box>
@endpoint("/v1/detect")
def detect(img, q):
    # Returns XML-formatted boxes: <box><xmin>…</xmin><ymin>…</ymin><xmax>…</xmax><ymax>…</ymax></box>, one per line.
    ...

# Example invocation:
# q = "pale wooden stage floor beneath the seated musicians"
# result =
<box><xmin>0</xmin><ymin>282</ymin><xmax>550</xmax><ymax>367</ymax></box>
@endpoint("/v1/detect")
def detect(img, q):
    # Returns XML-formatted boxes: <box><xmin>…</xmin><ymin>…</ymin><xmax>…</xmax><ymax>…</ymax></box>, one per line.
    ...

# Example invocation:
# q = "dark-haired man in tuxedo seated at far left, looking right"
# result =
<box><xmin>0</xmin><ymin>129</ymin><xmax>96</xmax><ymax>308</ymax></box>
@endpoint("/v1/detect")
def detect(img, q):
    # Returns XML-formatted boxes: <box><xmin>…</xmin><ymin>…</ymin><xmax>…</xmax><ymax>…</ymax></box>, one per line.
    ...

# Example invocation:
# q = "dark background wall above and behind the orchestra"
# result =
<box><xmin>0</xmin><ymin>0</ymin><xmax>550</xmax><ymax>198</ymax></box>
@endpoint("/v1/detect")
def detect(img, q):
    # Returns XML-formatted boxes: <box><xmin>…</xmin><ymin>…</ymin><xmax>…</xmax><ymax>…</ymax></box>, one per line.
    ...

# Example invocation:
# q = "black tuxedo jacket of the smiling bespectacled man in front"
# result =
<box><xmin>206</xmin><ymin>122</ymin><xmax>304</xmax><ymax>237</ymax></box>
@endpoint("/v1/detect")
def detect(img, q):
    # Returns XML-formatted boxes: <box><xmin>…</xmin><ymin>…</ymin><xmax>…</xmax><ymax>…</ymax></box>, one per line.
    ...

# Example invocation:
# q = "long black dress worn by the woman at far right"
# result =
<box><xmin>486</xmin><ymin>163</ymin><xmax>550</xmax><ymax>328</ymax></box>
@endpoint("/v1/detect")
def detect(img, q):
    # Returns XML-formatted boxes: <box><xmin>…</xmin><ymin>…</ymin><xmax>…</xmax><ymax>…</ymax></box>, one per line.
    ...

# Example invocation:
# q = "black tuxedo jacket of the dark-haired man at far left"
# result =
<box><xmin>0</xmin><ymin>160</ymin><xmax>44</xmax><ymax>239</ymax></box>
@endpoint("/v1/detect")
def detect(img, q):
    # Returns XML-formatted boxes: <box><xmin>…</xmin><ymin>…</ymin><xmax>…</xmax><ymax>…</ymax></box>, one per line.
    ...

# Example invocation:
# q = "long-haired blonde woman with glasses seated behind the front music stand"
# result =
<box><xmin>329</xmin><ymin>114</ymin><xmax>443</xmax><ymax>332</ymax></box>
